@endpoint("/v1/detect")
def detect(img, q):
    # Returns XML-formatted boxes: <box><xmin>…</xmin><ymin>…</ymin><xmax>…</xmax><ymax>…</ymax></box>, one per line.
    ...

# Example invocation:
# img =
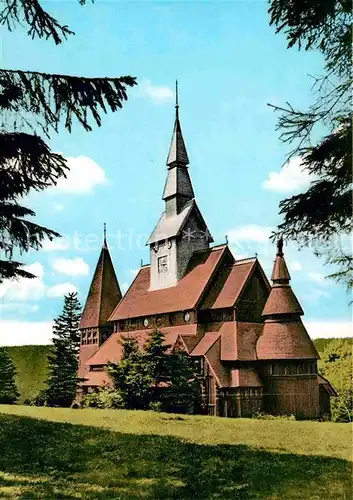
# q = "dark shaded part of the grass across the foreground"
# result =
<box><xmin>0</xmin><ymin>415</ymin><xmax>351</xmax><ymax>500</ymax></box>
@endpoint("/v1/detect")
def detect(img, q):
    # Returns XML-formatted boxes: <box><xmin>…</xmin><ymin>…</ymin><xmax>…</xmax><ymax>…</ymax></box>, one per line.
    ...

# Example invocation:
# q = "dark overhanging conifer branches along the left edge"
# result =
<box><xmin>0</xmin><ymin>0</ymin><xmax>136</xmax><ymax>282</ymax></box>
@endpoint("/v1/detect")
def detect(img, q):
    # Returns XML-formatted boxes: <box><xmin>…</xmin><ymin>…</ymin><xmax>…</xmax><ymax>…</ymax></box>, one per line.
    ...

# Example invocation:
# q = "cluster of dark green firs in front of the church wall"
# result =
<box><xmin>108</xmin><ymin>329</ymin><xmax>201</xmax><ymax>413</ymax></box>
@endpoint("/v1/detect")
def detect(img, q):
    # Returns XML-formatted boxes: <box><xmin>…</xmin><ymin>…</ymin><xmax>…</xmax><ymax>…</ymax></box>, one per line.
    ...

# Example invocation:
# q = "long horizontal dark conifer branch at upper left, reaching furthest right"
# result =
<box><xmin>0</xmin><ymin>69</ymin><xmax>136</xmax><ymax>136</ymax></box>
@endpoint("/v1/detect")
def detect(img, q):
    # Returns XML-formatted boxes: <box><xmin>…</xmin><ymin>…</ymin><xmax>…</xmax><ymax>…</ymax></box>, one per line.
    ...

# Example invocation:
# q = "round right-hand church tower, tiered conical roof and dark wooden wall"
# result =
<box><xmin>256</xmin><ymin>239</ymin><xmax>319</xmax><ymax>418</ymax></box>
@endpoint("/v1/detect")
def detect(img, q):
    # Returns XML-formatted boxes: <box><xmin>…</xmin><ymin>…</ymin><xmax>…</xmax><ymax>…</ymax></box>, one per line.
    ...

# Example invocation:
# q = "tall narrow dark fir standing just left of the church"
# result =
<box><xmin>45</xmin><ymin>293</ymin><xmax>81</xmax><ymax>407</ymax></box>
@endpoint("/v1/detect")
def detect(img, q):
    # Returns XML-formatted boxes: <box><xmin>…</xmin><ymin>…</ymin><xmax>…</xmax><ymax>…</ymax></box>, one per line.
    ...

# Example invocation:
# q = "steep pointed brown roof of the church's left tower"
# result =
<box><xmin>80</xmin><ymin>232</ymin><xmax>122</xmax><ymax>328</ymax></box>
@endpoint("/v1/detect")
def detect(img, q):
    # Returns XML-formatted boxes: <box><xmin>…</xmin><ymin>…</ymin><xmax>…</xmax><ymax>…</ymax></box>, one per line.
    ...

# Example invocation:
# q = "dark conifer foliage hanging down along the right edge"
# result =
<box><xmin>269</xmin><ymin>0</ymin><xmax>353</xmax><ymax>288</ymax></box>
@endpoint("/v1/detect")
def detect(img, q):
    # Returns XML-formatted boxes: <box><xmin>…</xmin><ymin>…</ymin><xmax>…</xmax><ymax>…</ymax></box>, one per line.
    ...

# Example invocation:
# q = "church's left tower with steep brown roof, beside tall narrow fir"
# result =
<box><xmin>79</xmin><ymin>225</ymin><xmax>122</xmax><ymax>375</ymax></box>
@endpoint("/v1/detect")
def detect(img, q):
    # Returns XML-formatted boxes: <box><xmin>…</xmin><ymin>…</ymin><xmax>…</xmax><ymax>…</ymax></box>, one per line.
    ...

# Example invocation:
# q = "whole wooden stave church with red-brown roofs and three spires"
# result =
<box><xmin>78</xmin><ymin>95</ymin><xmax>336</xmax><ymax>419</ymax></box>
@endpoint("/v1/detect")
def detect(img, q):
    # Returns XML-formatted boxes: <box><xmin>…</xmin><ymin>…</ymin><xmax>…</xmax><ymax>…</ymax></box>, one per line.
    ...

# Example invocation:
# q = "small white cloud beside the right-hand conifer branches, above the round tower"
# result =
<box><xmin>262</xmin><ymin>157</ymin><xmax>314</xmax><ymax>193</ymax></box>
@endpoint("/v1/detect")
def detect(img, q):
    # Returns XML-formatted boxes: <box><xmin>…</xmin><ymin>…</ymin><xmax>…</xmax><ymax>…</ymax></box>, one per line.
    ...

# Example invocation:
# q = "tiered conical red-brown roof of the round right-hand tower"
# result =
<box><xmin>256</xmin><ymin>239</ymin><xmax>319</xmax><ymax>360</ymax></box>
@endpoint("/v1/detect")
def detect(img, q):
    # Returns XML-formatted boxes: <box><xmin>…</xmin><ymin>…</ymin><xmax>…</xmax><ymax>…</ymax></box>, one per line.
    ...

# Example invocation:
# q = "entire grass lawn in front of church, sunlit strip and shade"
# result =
<box><xmin>0</xmin><ymin>405</ymin><xmax>352</xmax><ymax>500</ymax></box>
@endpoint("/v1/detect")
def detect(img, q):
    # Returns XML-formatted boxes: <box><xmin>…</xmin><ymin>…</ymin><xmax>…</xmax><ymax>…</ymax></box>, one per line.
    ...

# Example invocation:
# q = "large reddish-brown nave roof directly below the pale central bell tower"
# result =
<box><xmin>110</xmin><ymin>245</ymin><xmax>226</xmax><ymax>321</ymax></box>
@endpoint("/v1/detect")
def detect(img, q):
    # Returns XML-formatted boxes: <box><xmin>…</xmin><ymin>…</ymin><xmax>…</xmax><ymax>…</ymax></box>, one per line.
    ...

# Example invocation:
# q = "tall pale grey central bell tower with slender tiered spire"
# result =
<box><xmin>147</xmin><ymin>82</ymin><xmax>213</xmax><ymax>290</ymax></box>
